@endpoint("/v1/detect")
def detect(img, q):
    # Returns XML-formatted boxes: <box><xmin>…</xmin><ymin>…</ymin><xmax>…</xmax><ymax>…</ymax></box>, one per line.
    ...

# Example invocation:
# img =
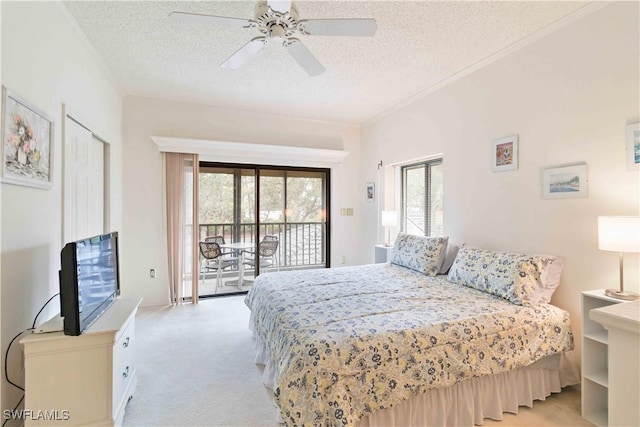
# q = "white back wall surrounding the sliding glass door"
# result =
<box><xmin>120</xmin><ymin>97</ymin><xmax>362</xmax><ymax>305</ymax></box>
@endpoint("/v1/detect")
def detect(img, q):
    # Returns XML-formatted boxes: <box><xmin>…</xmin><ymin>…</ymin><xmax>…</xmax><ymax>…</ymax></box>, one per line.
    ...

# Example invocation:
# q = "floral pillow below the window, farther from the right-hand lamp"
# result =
<box><xmin>391</xmin><ymin>233</ymin><xmax>449</xmax><ymax>276</ymax></box>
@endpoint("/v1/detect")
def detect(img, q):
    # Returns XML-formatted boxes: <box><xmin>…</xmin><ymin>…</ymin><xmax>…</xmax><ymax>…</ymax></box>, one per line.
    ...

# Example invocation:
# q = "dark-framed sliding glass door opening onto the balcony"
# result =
<box><xmin>199</xmin><ymin>162</ymin><xmax>329</xmax><ymax>296</ymax></box>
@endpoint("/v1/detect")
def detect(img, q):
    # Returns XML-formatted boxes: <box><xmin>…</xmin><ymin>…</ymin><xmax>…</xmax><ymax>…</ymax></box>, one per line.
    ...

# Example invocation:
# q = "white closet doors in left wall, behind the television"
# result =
<box><xmin>63</xmin><ymin>117</ymin><xmax>104</xmax><ymax>242</ymax></box>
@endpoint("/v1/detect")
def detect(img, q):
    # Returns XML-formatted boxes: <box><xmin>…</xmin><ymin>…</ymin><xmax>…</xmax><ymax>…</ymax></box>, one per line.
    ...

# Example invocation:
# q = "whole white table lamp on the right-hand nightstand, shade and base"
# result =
<box><xmin>598</xmin><ymin>216</ymin><xmax>640</xmax><ymax>300</ymax></box>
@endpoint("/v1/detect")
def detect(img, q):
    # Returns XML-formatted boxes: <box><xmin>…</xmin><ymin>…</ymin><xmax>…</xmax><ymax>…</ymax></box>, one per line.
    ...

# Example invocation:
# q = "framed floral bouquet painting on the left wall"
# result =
<box><xmin>0</xmin><ymin>86</ymin><xmax>54</xmax><ymax>188</ymax></box>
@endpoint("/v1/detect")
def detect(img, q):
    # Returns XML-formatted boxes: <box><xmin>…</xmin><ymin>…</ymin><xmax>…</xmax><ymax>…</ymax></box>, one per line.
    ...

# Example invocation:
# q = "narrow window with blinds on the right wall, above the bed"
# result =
<box><xmin>401</xmin><ymin>158</ymin><xmax>444</xmax><ymax>236</ymax></box>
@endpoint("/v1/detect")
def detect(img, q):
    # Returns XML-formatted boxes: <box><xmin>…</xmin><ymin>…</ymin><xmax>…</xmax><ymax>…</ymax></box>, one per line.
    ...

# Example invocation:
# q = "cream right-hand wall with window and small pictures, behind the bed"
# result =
<box><xmin>361</xmin><ymin>2</ymin><xmax>640</xmax><ymax>368</ymax></box>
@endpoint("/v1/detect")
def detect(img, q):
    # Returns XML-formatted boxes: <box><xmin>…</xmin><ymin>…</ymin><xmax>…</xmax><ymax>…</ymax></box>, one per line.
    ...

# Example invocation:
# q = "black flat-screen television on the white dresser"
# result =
<box><xmin>59</xmin><ymin>231</ymin><xmax>120</xmax><ymax>335</ymax></box>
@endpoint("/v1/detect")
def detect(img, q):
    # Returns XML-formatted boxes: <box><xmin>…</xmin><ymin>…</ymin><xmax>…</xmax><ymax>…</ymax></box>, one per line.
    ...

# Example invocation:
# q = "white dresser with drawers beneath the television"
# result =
<box><xmin>20</xmin><ymin>299</ymin><xmax>142</xmax><ymax>426</ymax></box>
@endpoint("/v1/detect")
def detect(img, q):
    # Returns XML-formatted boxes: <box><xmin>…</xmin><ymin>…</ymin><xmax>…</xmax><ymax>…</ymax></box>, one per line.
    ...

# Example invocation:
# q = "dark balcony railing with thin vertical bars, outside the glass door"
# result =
<box><xmin>195</xmin><ymin>222</ymin><xmax>326</xmax><ymax>268</ymax></box>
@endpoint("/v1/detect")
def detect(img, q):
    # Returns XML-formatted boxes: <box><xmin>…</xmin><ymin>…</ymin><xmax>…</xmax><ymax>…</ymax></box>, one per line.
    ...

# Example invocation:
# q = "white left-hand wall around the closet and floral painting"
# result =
<box><xmin>0</xmin><ymin>2</ymin><xmax>122</xmax><ymax>409</ymax></box>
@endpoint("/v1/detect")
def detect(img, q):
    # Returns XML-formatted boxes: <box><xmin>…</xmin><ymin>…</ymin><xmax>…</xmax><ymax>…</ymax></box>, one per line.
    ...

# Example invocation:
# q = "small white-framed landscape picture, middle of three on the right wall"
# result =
<box><xmin>542</xmin><ymin>163</ymin><xmax>588</xmax><ymax>199</ymax></box>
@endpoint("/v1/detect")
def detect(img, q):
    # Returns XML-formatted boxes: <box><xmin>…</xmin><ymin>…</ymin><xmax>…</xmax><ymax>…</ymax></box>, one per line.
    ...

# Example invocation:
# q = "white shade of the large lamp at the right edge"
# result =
<box><xmin>598</xmin><ymin>216</ymin><xmax>640</xmax><ymax>252</ymax></box>
